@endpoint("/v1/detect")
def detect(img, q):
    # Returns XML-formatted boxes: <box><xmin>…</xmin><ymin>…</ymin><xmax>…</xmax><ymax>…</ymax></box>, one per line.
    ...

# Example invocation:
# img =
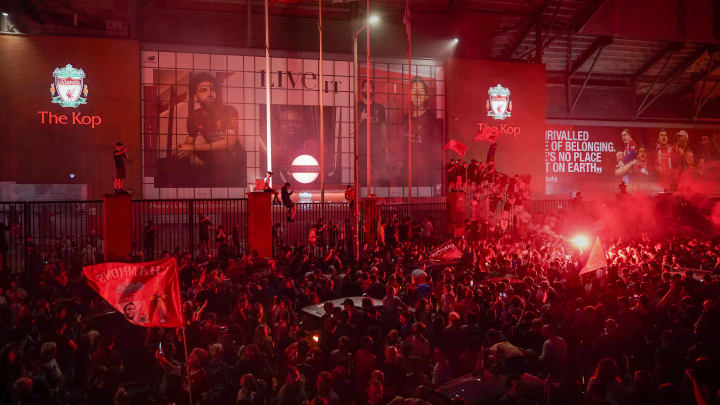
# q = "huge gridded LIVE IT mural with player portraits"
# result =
<box><xmin>139</xmin><ymin>44</ymin><xmax>446</xmax><ymax>199</ymax></box>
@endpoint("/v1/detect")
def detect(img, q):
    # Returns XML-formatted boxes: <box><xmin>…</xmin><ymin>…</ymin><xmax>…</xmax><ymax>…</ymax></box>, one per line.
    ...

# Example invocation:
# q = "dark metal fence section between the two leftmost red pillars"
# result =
<box><xmin>131</xmin><ymin>198</ymin><xmax>248</xmax><ymax>260</ymax></box>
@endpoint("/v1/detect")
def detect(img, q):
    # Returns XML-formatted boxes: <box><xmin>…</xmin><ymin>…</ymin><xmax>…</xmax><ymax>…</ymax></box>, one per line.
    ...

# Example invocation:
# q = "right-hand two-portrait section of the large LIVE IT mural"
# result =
<box><xmin>358</xmin><ymin>64</ymin><xmax>446</xmax><ymax>189</ymax></box>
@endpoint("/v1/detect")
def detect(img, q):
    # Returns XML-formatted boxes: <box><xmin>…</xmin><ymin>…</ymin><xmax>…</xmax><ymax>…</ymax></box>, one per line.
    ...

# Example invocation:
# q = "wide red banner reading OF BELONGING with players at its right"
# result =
<box><xmin>544</xmin><ymin>125</ymin><xmax>720</xmax><ymax>198</ymax></box>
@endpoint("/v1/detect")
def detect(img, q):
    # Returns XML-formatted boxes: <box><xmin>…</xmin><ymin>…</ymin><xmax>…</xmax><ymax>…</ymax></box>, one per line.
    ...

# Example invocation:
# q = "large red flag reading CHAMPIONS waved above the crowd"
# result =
<box><xmin>83</xmin><ymin>258</ymin><xmax>183</xmax><ymax>328</ymax></box>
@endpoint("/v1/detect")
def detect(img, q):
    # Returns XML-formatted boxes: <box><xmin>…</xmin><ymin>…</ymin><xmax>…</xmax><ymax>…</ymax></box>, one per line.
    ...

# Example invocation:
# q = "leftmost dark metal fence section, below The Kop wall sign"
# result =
<box><xmin>0</xmin><ymin>201</ymin><xmax>104</xmax><ymax>273</ymax></box>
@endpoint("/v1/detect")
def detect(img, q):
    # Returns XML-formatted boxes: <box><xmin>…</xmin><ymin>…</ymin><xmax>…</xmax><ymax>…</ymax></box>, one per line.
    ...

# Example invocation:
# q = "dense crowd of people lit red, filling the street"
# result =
<box><xmin>0</xmin><ymin>193</ymin><xmax>720</xmax><ymax>405</ymax></box>
